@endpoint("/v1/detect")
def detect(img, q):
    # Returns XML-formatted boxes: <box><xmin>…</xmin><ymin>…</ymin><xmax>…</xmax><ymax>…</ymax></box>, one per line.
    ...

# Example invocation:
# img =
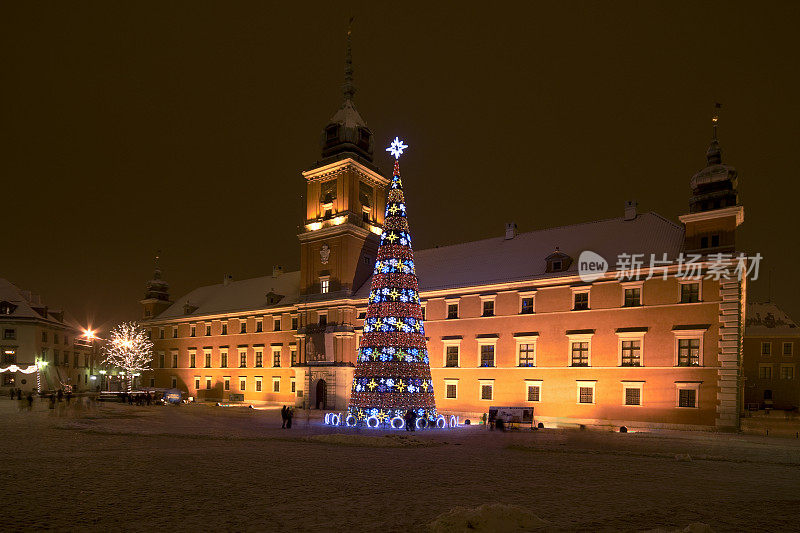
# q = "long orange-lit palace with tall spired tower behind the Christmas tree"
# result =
<box><xmin>142</xmin><ymin>50</ymin><xmax>746</xmax><ymax>429</ymax></box>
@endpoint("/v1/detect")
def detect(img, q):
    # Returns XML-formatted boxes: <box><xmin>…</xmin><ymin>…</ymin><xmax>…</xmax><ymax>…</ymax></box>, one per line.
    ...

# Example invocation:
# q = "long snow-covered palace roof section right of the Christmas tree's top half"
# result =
<box><xmin>356</xmin><ymin>213</ymin><xmax>683</xmax><ymax>298</ymax></box>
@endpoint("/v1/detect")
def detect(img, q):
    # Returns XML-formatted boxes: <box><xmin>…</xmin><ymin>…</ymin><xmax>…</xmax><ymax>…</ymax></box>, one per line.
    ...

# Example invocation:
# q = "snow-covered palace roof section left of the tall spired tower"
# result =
<box><xmin>158</xmin><ymin>270</ymin><xmax>300</xmax><ymax>319</ymax></box>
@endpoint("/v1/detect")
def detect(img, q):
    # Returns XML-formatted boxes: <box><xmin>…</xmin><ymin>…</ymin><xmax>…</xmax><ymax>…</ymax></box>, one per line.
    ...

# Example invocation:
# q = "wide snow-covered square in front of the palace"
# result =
<box><xmin>6</xmin><ymin>399</ymin><xmax>800</xmax><ymax>531</ymax></box>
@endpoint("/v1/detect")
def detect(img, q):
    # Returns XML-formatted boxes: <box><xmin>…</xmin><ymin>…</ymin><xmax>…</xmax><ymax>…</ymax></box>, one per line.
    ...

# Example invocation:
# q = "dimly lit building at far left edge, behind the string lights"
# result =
<box><xmin>0</xmin><ymin>279</ymin><xmax>96</xmax><ymax>392</ymax></box>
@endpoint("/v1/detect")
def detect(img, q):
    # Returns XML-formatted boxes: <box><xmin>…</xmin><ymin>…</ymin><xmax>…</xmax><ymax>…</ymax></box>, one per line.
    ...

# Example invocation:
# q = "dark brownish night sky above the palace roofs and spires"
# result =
<box><xmin>0</xmin><ymin>1</ymin><xmax>800</xmax><ymax>326</ymax></box>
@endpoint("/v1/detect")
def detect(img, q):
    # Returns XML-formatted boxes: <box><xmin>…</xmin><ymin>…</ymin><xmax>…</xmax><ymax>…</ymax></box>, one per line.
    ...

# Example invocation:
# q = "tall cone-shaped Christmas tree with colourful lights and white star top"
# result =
<box><xmin>347</xmin><ymin>137</ymin><xmax>436</xmax><ymax>427</ymax></box>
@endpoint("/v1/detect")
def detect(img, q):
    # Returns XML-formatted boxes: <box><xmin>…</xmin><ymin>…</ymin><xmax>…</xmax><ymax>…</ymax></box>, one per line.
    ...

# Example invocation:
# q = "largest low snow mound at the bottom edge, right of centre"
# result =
<box><xmin>428</xmin><ymin>503</ymin><xmax>551</xmax><ymax>533</ymax></box>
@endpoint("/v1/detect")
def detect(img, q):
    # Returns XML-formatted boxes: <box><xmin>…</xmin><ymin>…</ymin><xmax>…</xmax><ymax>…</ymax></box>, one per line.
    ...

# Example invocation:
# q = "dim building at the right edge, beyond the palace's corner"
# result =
<box><xmin>742</xmin><ymin>302</ymin><xmax>800</xmax><ymax>409</ymax></box>
